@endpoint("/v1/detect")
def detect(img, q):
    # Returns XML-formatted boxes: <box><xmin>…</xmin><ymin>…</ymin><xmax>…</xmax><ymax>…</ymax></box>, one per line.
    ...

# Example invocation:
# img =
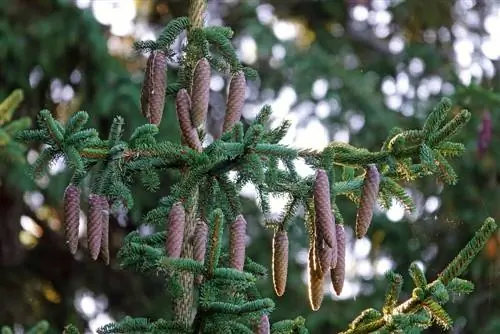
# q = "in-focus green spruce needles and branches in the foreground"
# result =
<box><xmin>0</xmin><ymin>0</ymin><xmax>497</xmax><ymax>333</ymax></box>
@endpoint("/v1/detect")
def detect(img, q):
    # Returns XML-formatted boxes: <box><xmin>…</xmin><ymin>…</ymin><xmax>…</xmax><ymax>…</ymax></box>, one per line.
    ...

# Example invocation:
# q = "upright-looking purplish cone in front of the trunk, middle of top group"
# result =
<box><xmin>191</xmin><ymin>58</ymin><xmax>210</xmax><ymax>128</ymax></box>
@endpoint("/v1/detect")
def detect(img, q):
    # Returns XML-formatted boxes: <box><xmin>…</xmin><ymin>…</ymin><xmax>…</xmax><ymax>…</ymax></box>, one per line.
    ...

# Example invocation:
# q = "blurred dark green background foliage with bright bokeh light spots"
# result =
<box><xmin>0</xmin><ymin>0</ymin><xmax>500</xmax><ymax>333</ymax></box>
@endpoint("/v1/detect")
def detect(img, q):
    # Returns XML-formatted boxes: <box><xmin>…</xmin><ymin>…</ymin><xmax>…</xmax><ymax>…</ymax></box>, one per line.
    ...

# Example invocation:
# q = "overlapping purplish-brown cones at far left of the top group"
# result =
<box><xmin>141</xmin><ymin>50</ymin><xmax>167</xmax><ymax>125</ymax></box>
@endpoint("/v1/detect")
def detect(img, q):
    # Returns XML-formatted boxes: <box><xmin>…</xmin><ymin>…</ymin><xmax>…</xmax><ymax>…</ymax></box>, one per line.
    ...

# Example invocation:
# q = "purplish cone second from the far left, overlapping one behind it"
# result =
<box><xmin>87</xmin><ymin>194</ymin><xmax>102</xmax><ymax>260</ymax></box>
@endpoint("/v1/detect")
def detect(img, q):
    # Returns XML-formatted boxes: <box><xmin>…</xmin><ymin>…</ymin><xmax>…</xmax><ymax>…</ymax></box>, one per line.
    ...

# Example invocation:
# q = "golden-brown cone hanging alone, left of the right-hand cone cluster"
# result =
<box><xmin>273</xmin><ymin>230</ymin><xmax>288</xmax><ymax>297</ymax></box>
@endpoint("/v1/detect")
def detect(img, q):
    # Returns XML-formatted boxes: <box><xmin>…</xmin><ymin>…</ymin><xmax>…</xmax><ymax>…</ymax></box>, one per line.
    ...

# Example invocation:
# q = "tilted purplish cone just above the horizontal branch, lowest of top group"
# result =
<box><xmin>175</xmin><ymin>88</ymin><xmax>202</xmax><ymax>152</ymax></box>
